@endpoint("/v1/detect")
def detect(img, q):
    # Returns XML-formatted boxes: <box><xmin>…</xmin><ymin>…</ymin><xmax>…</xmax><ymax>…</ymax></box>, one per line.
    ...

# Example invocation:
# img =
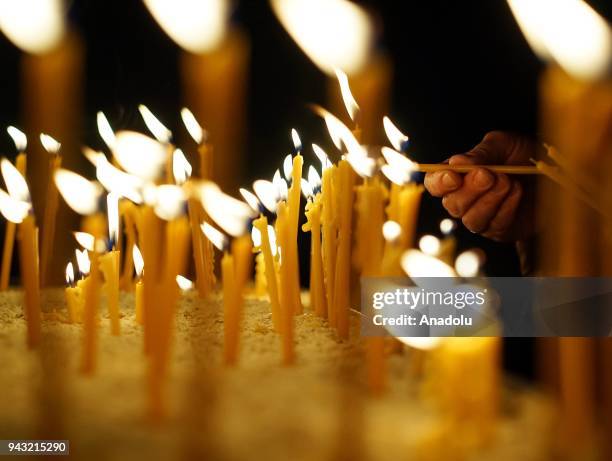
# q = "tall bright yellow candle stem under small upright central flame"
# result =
<box><xmin>283</xmin><ymin>154</ymin><xmax>303</xmax><ymax>314</ymax></box>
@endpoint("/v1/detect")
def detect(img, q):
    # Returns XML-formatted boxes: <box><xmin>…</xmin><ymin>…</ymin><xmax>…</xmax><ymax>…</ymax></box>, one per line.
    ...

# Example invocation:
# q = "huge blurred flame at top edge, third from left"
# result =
<box><xmin>271</xmin><ymin>0</ymin><xmax>374</xmax><ymax>75</ymax></box>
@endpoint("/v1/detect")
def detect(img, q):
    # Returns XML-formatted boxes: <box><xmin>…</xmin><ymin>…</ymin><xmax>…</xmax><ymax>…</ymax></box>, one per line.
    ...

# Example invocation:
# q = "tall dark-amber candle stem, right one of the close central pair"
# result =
<box><xmin>334</xmin><ymin>160</ymin><xmax>355</xmax><ymax>339</ymax></box>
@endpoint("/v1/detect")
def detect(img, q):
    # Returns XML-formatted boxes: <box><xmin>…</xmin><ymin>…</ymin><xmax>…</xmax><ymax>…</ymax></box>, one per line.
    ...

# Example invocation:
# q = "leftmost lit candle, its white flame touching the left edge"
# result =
<box><xmin>0</xmin><ymin>159</ymin><xmax>40</xmax><ymax>347</ymax></box>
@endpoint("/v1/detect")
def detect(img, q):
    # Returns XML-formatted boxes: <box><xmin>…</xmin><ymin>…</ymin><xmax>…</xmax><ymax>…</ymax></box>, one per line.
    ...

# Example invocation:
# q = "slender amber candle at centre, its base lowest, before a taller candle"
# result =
<box><xmin>276</xmin><ymin>202</ymin><xmax>295</xmax><ymax>365</ymax></box>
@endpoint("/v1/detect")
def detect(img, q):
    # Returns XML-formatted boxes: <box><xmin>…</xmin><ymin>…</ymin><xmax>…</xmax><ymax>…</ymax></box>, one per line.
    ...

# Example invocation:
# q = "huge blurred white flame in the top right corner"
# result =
<box><xmin>508</xmin><ymin>0</ymin><xmax>612</xmax><ymax>79</ymax></box>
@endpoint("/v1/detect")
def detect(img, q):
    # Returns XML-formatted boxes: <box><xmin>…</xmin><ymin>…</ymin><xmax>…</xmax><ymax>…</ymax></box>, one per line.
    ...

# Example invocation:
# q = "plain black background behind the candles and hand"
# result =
<box><xmin>0</xmin><ymin>0</ymin><xmax>609</xmax><ymax>374</ymax></box>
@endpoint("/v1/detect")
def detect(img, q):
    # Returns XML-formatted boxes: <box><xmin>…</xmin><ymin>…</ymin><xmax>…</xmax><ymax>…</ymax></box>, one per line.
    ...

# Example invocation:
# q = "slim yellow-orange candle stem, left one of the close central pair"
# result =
<box><xmin>321</xmin><ymin>166</ymin><xmax>338</xmax><ymax>327</ymax></box>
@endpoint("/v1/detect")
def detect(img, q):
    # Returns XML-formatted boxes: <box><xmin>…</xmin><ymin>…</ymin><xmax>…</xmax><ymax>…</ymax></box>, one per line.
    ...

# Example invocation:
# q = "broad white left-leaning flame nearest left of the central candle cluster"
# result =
<box><xmin>200</xmin><ymin>182</ymin><xmax>256</xmax><ymax>237</ymax></box>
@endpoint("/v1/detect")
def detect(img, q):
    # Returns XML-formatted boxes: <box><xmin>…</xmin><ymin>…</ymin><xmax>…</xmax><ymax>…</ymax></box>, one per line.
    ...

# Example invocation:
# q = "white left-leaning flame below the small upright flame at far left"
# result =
<box><xmin>54</xmin><ymin>169</ymin><xmax>104</xmax><ymax>215</ymax></box>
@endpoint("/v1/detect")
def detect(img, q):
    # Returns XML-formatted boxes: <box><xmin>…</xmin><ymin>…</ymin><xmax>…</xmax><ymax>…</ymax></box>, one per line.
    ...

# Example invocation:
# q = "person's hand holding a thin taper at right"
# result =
<box><xmin>425</xmin><ymin>131</ymin><xmax>537</xmax><ymax>242</ymax></box>
